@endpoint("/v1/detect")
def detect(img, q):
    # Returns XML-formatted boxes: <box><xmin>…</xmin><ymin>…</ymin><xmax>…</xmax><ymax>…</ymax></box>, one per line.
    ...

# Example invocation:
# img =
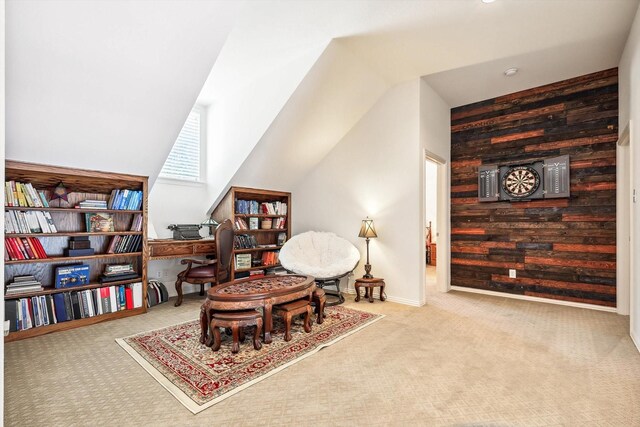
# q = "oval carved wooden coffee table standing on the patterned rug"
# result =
<box><xmin>200</xmin><ymin>274</ymin><xmax>316</xmax><ymax>344</ymax></box>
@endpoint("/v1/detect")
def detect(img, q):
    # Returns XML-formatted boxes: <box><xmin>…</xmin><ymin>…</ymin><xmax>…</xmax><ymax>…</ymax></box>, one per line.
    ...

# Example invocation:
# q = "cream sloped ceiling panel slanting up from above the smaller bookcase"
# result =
<box><xmin>214</xmin><ymin>41</ymin><xmax>388</xmax><ymax>208</ymax></box>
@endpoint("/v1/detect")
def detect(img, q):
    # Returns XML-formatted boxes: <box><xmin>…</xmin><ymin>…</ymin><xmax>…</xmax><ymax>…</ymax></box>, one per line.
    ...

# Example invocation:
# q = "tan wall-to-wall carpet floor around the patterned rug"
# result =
<box><xmin>4</xmin><ymin>280</ymin><xmax>640</xmax><ymax>426</ymax></box>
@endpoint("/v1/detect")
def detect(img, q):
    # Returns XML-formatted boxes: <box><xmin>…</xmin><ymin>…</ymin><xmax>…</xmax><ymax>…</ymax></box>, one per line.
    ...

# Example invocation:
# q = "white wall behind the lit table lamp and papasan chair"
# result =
<box><xmin>292</xmin><ymin>79</ymin><xmax>424</xmax><ymax>305</ymax></box>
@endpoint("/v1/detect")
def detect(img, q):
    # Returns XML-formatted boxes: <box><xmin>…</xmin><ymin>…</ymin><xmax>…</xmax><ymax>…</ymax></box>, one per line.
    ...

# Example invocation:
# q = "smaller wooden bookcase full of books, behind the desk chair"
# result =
<box><xmin>212</xmin><ymin>187</ymin><xmax>291</xmax><ymax>279</ymax></box>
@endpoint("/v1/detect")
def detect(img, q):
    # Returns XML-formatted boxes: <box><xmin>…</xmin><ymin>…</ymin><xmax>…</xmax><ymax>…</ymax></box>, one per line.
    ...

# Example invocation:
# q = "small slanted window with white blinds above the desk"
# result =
<box><xmin>159</xmin><ymin>107</ymin><xmax>204</xmax><ymax>182</ymax></box>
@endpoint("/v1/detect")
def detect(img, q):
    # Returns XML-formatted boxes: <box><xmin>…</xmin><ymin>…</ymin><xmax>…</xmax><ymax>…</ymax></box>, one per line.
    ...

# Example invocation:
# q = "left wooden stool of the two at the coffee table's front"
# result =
<box><xmin>210</xmin><ymin>310</ymin><xmax>262</xmax><ymax>353</ymax></box>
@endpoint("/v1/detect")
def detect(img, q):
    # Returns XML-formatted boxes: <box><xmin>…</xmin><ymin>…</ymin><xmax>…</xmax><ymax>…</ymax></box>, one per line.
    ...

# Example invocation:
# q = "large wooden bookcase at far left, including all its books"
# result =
<box><xmin>4</xmin><ymin>160</ymin><xmax>147</xmax><ymax>342</ymax></box>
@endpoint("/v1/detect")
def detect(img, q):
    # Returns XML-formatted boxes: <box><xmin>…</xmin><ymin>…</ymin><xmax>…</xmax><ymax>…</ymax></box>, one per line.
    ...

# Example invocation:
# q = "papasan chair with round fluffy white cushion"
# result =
<box><xmin>279</xmin><ymin>231</ymin><xmax>360</xmax><ymax>305</ymax></box>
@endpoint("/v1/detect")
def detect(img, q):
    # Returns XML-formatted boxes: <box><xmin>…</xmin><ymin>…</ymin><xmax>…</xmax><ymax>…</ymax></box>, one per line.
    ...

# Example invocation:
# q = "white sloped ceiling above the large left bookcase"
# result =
<box><xmin>6</xmin><ymin>0</ymin><xmax>239</xmax><ymax>180</ymax></box>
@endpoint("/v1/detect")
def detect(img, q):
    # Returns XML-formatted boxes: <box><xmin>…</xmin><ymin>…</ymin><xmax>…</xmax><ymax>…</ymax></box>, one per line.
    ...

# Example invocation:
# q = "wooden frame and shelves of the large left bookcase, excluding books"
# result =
<box><xmin>4</xmin><ymin>160</ymin><xmax>148</xmax><ymax>342</ymax></box>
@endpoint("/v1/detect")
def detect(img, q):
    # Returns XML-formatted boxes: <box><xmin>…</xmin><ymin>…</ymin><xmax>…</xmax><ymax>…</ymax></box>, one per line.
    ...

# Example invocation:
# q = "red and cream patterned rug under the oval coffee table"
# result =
<box><xmin>116</xmin><ymin>306</ymin><xmax>384</xmax><ymax>414</ymax></box>
